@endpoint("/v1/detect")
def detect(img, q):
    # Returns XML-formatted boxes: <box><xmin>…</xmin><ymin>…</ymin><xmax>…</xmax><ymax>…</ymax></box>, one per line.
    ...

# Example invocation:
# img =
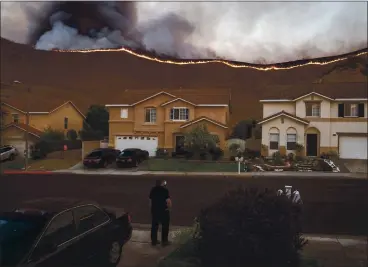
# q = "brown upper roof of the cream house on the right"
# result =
<box><xmin>261</xmin><ymin>82</ymin><xmax>368</xmax><ymax>101</ymax></box>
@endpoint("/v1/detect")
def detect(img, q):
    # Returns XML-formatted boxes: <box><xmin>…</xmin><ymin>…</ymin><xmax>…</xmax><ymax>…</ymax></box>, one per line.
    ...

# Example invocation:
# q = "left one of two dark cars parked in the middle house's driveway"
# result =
<box><xmin>83</xmin><ymin>148</ymin><xmax>120</xmax><ymax>168</ymax></box>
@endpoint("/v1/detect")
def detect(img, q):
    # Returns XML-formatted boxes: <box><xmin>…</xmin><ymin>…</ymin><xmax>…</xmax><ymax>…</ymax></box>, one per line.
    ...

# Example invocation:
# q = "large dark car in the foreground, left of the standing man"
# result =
<box><xmin>0</xmin><ymin>200</ymin><xmax>132</xmax><ymax>267</ymax></box>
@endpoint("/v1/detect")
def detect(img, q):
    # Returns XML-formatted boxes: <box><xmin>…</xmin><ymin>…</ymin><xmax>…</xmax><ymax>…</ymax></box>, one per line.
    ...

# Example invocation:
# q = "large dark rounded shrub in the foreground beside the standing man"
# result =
<box><xmin>197</xmin><ymin>188</ymin><xmax>306</xmax><ymax>267</ymax></box>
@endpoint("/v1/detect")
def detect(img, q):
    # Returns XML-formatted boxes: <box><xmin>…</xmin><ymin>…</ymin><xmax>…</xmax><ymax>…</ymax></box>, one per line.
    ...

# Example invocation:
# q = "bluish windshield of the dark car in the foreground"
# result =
<box><xmin>0</xmin><ymin>212</ymin><xmax>47</xmax><ymax>266</ymax></box>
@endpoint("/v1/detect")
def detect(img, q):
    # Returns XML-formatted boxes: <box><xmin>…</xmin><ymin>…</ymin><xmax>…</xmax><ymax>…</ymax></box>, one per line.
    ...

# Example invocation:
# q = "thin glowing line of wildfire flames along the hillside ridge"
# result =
<box><xmin>53</xmin><ymin>47</ymin><xmax>368</xmax><ymax>71</ymax></box>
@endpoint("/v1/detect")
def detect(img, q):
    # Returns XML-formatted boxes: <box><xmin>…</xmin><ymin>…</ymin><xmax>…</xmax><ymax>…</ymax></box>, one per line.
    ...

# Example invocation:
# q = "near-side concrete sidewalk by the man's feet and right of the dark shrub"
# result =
<box><xmin>127</xmin><ymin>224</ymin><xmax>368</xmax><ymax>267</ymax></box>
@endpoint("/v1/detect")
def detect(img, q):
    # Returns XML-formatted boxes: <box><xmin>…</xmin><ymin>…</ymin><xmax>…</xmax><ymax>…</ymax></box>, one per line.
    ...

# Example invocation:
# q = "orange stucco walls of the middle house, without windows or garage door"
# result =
<box><xmin>109</xmin><ymin>94</ymin><xmax>228</xmax><ymax>151</ymax></box>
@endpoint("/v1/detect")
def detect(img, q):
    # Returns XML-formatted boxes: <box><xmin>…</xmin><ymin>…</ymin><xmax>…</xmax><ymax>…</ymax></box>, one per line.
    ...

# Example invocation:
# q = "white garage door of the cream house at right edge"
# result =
<box><xmin>339</xmin><ymin>136</ymin><xmax>368</xmax><ymax>159</ymax></box>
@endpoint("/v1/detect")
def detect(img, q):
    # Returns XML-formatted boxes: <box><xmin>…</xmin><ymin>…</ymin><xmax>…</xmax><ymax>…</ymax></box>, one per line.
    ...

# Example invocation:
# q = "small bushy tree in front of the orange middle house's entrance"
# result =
<box><xmin>184</xmin><ymin>124</ymin><xmax>219</xmax><ymax>159</ymax></box>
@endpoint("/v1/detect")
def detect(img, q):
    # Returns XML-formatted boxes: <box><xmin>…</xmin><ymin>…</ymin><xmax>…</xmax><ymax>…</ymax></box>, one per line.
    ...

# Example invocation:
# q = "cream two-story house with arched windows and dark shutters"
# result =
<box><xmin>259</xmin><ymin>83</ymin><xmax>368</xmax><ymax>159</ymax></box>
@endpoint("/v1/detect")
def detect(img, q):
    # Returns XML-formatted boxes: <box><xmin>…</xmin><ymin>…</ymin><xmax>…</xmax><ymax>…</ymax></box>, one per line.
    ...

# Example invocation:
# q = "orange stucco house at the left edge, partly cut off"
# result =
<box><xmin>1</xmin><ymin>101</ymin><xmax>85</xmax><ymax>155</ymax></box>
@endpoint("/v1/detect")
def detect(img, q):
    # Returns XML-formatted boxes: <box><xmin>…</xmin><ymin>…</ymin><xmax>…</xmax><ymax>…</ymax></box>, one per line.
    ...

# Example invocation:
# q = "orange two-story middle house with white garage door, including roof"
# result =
<box><xmin>106</xmin><ymin>91</ymin><xmax>229</xmax><ymax>156</ymax></box>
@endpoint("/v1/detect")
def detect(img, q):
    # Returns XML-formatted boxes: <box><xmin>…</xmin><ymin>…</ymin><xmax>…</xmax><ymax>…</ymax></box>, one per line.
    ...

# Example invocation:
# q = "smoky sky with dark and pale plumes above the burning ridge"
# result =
<box><xmin>1</xmin><ymin>1</ymin><xmax>368</xmax><ymax>63</ymax></box>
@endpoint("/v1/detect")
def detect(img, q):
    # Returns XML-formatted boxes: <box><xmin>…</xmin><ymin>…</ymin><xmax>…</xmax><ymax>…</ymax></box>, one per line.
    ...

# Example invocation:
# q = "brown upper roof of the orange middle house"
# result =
<box><xmin>106</xmin><ymin>89</ymin><xmax>229</xmax><ymax>106</ymax></box>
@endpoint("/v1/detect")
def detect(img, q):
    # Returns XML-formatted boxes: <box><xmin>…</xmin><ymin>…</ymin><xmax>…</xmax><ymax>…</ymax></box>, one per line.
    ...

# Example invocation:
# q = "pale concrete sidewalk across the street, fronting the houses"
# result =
<box><xmin>54</xmin><ymin>169</ymin><xmax>368</xmax><ymax>179</ymax></box>
